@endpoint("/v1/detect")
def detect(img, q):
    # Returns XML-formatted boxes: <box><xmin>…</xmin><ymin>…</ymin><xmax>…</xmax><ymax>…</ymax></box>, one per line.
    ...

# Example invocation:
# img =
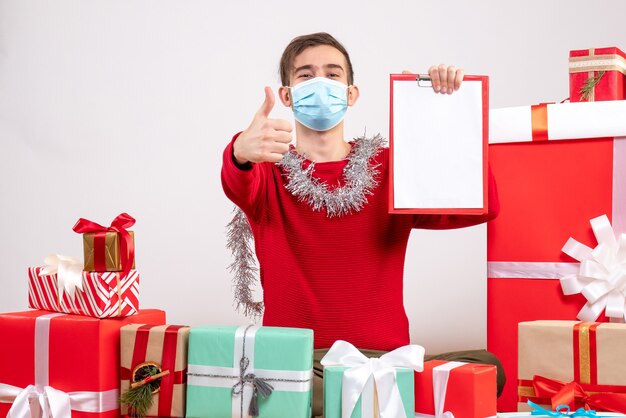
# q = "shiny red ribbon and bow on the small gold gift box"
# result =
<box><xmin>72</xmin><ymin>213</ymin><xmax>135</xmax><ymax>281</ymax></box>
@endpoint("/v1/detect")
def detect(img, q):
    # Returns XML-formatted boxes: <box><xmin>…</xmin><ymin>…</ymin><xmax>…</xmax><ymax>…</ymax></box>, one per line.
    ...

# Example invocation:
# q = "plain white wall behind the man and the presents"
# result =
<box><xmin>0</xmin><ymin>0</ymin><xmax>626</xmax><ymax>352</ymax></box>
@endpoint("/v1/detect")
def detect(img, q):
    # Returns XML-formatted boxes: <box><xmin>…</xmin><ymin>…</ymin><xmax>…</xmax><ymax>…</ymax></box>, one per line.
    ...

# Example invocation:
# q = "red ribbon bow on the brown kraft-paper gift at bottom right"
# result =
<box><xmin>533</xmin><ymin>376</ymin><xmax>626</xmax><ymax>414</ymax></box>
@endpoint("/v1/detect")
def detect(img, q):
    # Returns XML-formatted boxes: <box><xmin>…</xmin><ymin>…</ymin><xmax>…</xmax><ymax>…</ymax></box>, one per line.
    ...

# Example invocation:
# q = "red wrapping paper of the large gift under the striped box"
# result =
<box><xmin>0</xmin><ymin>309</ymin><xmax>165</xmax><ymax>418</ymax></box>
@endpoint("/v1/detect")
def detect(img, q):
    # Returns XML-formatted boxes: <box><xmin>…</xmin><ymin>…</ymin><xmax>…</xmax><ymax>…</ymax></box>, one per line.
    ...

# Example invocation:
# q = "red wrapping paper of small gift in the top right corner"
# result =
<box><xmin>569</xmin><ymin>47</ymin><xmax>626</xmax><ymax>102</ymax></box>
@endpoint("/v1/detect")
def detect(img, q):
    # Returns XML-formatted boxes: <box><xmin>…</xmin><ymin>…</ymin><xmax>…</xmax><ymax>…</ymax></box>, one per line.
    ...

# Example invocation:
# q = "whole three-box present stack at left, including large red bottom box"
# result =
<box><xmin>0</xmin><ymin>214</ymin><xmax>171</xmax><ymax>418</ymax></box>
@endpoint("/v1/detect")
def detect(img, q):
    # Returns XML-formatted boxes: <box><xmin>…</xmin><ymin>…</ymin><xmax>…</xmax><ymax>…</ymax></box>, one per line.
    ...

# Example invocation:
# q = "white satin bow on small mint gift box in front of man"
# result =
<box><xmin>321</xmin><ymin>340</ymin><xmax>424</xmax><ymax>418</ymax></box>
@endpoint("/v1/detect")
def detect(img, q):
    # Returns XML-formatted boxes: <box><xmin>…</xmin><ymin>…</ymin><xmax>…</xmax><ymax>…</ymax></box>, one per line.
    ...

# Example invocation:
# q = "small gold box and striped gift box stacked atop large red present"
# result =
<box><xmin>28</xmin><ymin>213</ymin><xmax>139</xmax><ymax>318</ymax></box>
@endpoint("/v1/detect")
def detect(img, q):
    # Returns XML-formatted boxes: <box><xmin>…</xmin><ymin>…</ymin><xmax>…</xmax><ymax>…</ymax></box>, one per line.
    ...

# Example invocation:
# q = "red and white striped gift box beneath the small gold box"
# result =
<box><xmin>28</xmin><ymin>267</ymin><xmax>139</xmax><ymax>318</ymax></box>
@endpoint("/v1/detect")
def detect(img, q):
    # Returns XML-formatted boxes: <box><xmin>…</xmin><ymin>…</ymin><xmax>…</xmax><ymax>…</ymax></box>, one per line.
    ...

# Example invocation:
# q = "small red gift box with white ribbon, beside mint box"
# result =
<box><xmin>415</xmin><ymin>360</ymin><xmax>497</xmax><ymax>418</ymax></box>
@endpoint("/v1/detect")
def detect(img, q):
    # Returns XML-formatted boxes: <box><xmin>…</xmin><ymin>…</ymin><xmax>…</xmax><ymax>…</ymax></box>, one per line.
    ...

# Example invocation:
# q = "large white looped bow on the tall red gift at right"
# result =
<box><xmin>561</xmin><ymin>215</ymin><xmax>626</xmax><ymax>322</ymax></box>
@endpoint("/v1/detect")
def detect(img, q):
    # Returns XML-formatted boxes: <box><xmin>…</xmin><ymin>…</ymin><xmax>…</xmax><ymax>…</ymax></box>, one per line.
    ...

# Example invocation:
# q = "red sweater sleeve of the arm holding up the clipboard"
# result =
<box><xmin>413</xmin><ymin>163</ymin><xmax>500</xmax><ymax>229</ymax></box>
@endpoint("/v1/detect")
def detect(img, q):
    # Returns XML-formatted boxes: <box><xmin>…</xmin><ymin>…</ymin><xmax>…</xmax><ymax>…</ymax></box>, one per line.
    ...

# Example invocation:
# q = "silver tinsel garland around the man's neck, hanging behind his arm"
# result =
<box><xmin>226</xmin><ymin>135</ymin><xmax>385</xmax><ymax>319</ymax></box>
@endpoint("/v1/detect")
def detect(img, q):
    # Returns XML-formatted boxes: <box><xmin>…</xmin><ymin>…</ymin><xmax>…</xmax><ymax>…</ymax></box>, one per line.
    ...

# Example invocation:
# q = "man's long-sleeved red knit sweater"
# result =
<box><xmin>222</xmin><ymin>136</ymin><xmax>499</xmax><ymax>350</ymax></box>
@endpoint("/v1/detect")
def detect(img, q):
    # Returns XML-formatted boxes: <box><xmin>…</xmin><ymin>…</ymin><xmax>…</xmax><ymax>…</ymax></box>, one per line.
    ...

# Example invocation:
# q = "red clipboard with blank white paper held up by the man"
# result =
<box><xmin>389</xmin><ymin>74</ymin><xmax>489</xmax><ymax>215</ymax></box>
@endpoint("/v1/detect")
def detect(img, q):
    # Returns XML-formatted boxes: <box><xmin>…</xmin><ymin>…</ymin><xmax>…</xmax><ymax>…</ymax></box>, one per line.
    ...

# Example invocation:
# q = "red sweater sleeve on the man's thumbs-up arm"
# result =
<box><xmin>222</xmin><ymin>132</ymin><xmax>266</xmax><ymax>217</ymax></box>
